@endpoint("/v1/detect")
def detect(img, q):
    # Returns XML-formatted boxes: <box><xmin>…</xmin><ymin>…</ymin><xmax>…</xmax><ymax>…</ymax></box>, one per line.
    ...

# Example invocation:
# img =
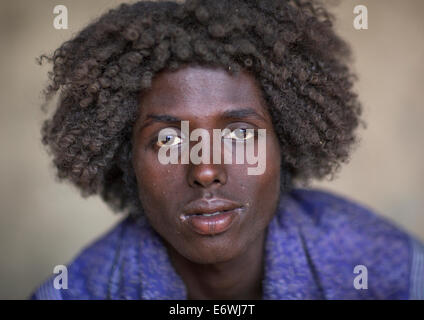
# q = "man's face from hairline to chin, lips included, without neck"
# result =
<box><xmin>132</xmin><ymin>66</ymin><xmax>280</xmax><ymax>263</ymax></box>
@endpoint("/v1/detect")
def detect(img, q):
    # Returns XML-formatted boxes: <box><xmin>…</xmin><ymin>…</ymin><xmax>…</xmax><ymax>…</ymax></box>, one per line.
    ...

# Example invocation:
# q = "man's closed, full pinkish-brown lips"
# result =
<box><xmin>181</xmin><ymin>198</ymin><xmax>243</xmax><ymax>235</ymax></box>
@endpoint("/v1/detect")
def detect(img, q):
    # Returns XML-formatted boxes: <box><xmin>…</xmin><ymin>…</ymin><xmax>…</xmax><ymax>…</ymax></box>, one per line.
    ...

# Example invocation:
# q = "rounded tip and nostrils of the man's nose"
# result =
<box><xmin>188</xmin><ymin>163</ymin><xmax>227</xmax><ymax>188</ymax></box>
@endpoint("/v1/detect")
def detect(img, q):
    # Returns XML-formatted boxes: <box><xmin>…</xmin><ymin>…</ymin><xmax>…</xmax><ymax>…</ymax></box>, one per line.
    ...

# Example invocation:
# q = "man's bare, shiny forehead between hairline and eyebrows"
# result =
<box><xmin>140</xmin><ymin>66</ymin><xmax>265</xmax><ymax>117</ymax></box>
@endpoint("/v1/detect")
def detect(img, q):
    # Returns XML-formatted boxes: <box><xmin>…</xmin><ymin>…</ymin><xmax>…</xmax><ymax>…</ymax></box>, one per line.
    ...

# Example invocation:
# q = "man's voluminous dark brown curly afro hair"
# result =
<box><xmin>39</xmin><ymin>0</ymin><xmax>361</xmax><ymax>212</ymax></box>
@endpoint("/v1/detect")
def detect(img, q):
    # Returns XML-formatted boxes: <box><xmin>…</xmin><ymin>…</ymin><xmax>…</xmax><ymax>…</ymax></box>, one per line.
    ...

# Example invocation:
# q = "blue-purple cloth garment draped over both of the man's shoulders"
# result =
<box><xmin>32</xmin><ymin>189</ymin><xmax>424</xmax><ymax>299</ymax></box>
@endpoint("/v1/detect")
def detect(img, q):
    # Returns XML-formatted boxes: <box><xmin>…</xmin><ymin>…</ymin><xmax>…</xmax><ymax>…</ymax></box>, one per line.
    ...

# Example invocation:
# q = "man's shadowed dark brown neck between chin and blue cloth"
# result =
<box><xmin>167</xmin><ymin>231</ymin><xmax>266</xmax><ymax>300</ymax></box>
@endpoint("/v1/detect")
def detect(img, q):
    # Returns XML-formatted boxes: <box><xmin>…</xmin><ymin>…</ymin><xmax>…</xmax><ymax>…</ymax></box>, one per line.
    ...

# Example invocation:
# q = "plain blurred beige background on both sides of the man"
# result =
<box><xmin>0</xmin><ymin>0</ymin><xmax>424</xmax><ymax>299</ymax></box>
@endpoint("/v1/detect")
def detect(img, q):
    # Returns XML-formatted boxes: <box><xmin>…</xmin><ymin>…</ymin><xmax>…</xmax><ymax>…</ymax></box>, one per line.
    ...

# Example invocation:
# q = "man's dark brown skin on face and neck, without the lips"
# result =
<box><xmin>132</xmin><ymin>66</ymin><xmax>281</xmax><ymax>299</ymax></box>
